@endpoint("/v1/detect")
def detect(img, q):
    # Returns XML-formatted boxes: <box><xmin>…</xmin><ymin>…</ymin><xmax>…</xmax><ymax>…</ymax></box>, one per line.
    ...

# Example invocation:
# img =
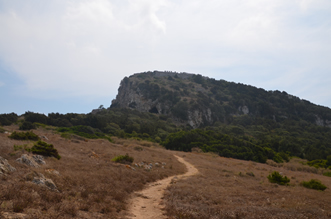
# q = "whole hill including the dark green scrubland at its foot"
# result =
<box><xmin>0</xmin><ymin>71</ymin><xmax>331</xmax><ymax>163</ymax></box>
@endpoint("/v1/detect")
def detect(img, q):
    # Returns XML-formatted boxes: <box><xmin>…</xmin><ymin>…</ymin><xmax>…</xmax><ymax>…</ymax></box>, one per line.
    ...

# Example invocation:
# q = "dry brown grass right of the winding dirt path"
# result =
<box><xmin>165</xmin><ymin>152</ymin><xmax>331</xmax><ymax>219</ymax></box>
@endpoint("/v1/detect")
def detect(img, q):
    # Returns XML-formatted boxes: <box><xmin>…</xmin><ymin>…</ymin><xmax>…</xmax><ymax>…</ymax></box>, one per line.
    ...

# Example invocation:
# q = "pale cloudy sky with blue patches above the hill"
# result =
<box><xmin>0</xmin><ymin>0</ymin><xmax>331</xmax><ymax>115</ymax></box>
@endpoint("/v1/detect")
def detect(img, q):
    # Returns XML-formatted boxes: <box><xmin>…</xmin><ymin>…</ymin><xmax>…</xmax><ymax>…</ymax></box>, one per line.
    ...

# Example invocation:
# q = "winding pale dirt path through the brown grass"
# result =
<box><xmin>127</xmin><ymin>155</ymin><xmax>199</xmax><ymax>219</ymax></box>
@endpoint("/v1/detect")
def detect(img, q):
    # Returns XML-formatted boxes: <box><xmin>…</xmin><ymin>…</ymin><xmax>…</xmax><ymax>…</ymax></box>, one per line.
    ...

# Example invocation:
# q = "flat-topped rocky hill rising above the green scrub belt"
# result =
<box><xmin>111</xmin><ymin>71</ymin><xmax>331</xmax><ymax>128</ymax></box>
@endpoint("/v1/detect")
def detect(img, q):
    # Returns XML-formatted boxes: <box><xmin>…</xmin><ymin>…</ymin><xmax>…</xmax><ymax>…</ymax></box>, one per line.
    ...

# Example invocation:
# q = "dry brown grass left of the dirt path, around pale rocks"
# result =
<box><xmin>0</xmin><ymin>126</ymin><xmax>185</xmax><ymax>218</ymax></box>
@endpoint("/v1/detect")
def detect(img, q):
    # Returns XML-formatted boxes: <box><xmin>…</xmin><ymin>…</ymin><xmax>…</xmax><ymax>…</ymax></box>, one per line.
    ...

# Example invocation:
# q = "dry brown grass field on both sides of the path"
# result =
<box><xmin>0</xmin><ymin>125</ymin><xmax>331</xmax><ymax>219</ymax></box>
